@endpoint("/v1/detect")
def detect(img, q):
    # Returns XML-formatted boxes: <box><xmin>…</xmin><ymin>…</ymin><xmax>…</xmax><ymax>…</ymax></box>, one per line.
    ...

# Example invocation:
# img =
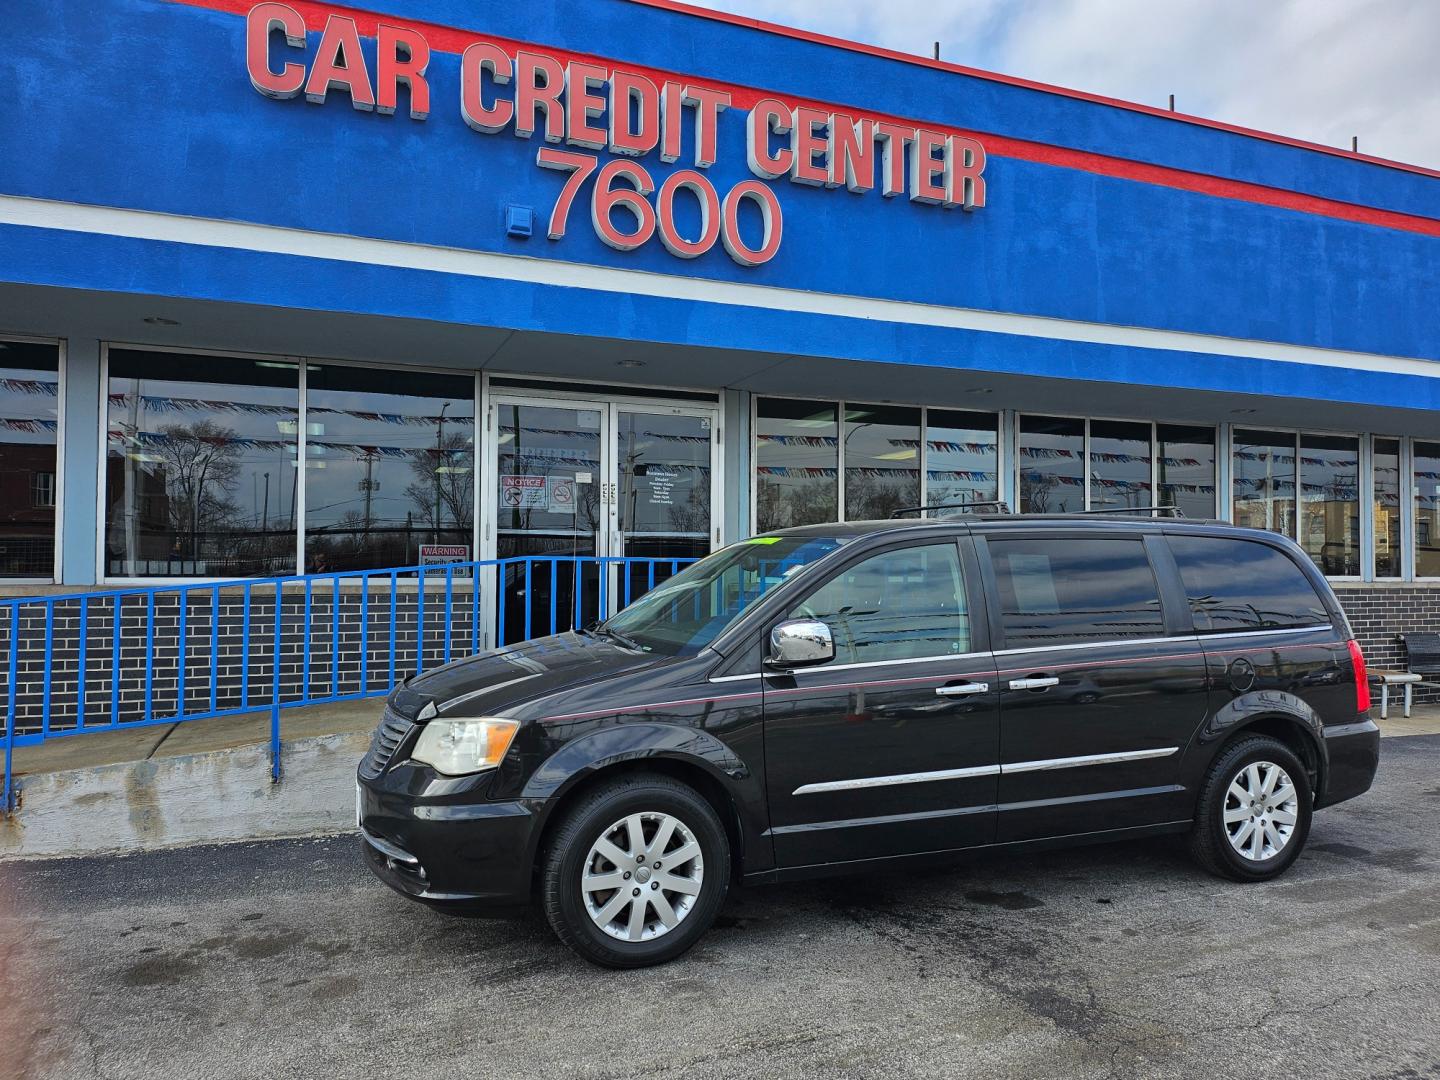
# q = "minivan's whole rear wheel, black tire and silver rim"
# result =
<box><xmin>1189</xmin><ymin>734</ymin><xmax>1313</xmax><ymax>881</ymax></box>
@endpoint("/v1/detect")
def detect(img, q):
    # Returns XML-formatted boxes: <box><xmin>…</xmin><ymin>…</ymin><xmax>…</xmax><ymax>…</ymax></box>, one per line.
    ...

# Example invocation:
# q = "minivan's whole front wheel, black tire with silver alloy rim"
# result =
<box><xmin>540</xmin><ymin>776</ymin><xmax>730</xmax><ymax>968</ymax></box>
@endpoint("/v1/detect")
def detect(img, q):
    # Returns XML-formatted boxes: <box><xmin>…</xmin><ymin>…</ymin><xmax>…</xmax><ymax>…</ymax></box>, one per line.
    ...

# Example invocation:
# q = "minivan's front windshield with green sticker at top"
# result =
<box><xmin>600</xmin><ymin>536</ymin><xmax>845</xmax><ymax>657</ymax></box>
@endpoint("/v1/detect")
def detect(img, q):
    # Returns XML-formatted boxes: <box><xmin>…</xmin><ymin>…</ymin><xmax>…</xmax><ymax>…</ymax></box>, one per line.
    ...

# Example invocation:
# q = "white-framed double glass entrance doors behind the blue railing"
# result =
<box><xmin>482</xmin><ymin>395</ymin><xmax>721</xmax><ymax>644</ymax></box>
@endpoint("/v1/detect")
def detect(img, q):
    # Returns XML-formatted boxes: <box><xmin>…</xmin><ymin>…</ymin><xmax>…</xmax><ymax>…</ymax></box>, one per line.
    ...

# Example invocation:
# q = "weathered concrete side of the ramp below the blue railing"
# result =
<box><xmin>0</xmin><ymin>732</ymin><xmax>370</xmax><ymax>861</ymax></box>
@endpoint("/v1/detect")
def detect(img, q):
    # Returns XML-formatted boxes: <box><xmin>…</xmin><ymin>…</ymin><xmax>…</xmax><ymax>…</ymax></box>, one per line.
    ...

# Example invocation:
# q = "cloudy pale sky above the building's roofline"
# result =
<box><xmin>690</xmin><ymin>0</ymin><xmax>1440</xmax><ymax>167</ymax></box>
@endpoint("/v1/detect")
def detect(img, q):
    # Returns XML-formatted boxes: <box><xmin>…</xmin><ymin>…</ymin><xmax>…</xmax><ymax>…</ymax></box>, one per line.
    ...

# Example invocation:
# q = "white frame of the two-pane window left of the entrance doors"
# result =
<box><xmin>100</xmin><ymin>341</ymin><xmax>485</xmax><ymax>588</ymax></box>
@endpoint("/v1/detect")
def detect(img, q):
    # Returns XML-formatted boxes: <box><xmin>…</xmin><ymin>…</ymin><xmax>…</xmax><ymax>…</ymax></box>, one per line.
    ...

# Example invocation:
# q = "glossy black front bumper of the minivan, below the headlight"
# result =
<box><xmin>357</xmin><ymin>766</ymin><xmax>539</xmax><ymax>912</ymax></box>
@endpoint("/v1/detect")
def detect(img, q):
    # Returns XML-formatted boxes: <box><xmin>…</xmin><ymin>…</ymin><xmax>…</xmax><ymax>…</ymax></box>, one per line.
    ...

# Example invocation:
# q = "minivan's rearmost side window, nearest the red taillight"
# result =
<box><xmin>1166</xmin><ymin>536</ymin><xmax>1331</xmax><ymax>634</ymax></box>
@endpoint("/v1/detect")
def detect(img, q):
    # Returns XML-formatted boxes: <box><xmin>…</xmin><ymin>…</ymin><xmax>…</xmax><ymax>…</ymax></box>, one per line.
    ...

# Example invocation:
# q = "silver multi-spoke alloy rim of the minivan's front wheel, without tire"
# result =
<box><xmin>580</xmin><ymin>812</ymin><xmax>704</xmax><ymax>942</ymax></box>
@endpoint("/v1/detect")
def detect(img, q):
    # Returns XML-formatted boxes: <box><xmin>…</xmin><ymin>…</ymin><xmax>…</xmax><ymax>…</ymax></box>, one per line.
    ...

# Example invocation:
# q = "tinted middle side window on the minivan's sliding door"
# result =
<box><xmin>988</xmin><ymin>537</ymin><xmax>1165</xmax><ymax>648</ymax></box>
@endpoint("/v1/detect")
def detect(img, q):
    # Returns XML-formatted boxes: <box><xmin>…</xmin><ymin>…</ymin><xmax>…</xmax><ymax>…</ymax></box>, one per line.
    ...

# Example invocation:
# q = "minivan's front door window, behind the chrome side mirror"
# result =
<box><xmin>789</xmin><ymin>544</ymin><xmax>971</xmax><ymax>664</ymax></box>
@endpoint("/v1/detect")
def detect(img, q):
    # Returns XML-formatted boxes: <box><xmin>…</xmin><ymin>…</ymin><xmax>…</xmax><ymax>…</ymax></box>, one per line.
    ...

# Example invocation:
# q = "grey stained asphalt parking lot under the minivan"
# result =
<box><xmin>0</xmin><ymin>736</ymin><xmax>1440</xmax><ymax>1080</ymax></box>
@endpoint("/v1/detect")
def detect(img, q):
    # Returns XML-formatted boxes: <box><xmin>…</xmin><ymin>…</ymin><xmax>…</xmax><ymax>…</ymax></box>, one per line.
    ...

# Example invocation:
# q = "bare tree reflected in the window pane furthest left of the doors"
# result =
<box><xmin>154</xmin><ymin>420</ymin><xmax>240</xmax><ymax>559</ymax></box>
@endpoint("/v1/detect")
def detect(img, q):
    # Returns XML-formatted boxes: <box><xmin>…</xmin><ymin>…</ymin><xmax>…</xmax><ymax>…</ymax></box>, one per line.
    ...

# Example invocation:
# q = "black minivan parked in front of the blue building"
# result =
<box><xmin>359</xmin><ymin>516</ymin><xmax>1380</xmax><ymax>968</ymax></box>
